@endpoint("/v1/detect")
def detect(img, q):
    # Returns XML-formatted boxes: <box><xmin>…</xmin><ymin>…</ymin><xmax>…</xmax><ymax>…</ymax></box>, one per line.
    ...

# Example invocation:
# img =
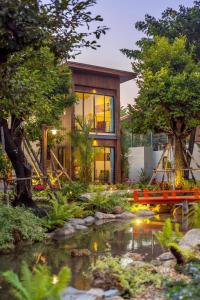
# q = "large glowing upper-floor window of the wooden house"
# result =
<box><xmin>75</xmin><ymin>92</ymin><xmax>115</xmax><ymax>133</ymax></box>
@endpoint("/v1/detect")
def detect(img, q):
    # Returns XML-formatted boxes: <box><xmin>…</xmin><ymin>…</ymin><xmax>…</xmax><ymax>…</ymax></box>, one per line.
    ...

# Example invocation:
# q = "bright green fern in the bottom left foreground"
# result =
<box><xmin>2</xmin><ymin>263</ymin><xmax>71</xmax><ymax>300</ymax></box>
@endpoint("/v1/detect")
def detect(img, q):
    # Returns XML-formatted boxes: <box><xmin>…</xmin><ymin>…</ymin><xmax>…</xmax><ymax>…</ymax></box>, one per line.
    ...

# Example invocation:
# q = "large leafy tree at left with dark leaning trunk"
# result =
<box><xmin>0</xmin><ymin>0</ymin><xmax>107</xmax><ymax>206</ymax></box>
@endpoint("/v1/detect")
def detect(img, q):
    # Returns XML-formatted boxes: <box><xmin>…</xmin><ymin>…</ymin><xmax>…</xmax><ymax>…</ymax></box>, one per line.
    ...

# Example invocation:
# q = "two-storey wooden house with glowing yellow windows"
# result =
<box><xmin>56</xmin><ymin>62</ymin><xmax>135</xmax><ymax>183</ymax></box>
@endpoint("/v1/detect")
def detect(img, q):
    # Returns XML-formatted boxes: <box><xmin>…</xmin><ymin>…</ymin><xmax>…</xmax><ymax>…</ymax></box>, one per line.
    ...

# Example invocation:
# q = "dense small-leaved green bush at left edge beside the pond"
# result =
<box><xmin>0</xmin><ymin>205</ymin><xmax>45</xmax><ymax>250</ymax></box>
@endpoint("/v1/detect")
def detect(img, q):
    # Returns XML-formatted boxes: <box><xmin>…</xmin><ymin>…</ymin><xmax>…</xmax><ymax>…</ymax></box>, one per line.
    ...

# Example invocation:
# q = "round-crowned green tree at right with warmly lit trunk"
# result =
<box><xmin>122</xmin><ymin>37</ymin><xmax>200</xmax><ymax>186</ymax></box>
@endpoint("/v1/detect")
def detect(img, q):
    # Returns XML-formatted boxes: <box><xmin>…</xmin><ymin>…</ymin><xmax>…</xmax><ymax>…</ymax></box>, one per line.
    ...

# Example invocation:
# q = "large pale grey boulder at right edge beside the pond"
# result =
<box><xmin>179</xmin><ymin>229</ymin><xmax>200</xmax><ymax>249</ymax></box>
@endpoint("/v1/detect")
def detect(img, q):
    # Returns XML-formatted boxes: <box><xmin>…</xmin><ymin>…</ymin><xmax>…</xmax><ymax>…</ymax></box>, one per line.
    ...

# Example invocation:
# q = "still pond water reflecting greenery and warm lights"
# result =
<box><xmin>0</xmin><ymin>215</ymin><xmax>189</xmax><ymax>300</ymax></box>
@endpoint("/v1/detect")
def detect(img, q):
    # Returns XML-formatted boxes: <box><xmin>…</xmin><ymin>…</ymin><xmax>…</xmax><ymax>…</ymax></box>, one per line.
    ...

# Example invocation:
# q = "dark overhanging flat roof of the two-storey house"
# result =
<box><xmin>68</xmin><ymin>61</ymin><xmax>136</xmax><ymax>83</ymax></box>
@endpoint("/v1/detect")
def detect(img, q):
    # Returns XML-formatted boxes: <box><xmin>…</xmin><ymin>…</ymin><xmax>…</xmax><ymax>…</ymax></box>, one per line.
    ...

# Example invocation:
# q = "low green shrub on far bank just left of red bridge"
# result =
<box><xmin>83</xmin><ymin>192</ymin><xmax>129</xmax><ymax>213</ymax></box>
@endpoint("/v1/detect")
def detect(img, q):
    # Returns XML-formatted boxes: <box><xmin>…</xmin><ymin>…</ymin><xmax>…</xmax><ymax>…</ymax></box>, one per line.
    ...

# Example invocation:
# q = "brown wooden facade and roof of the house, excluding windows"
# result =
<box><xmin>57</xmin><ymin>62</ymin><xmax>135</xmax><ymax>182</ymax></box>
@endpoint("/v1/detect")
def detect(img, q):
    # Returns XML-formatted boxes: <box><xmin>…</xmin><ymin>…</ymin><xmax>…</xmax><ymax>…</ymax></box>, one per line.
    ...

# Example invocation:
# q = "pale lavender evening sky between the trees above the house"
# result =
<box><xmin>75</xmin><ymin>0</ymin><xmax>193</xmax><ymax>105</ymax></box>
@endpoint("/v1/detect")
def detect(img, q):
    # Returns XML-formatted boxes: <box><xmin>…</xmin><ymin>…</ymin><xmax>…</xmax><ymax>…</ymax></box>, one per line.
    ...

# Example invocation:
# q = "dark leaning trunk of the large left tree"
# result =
<box><xmin>0</xmin><ymin>118</ymin><xmax>36</xmax><ymax>207</ymax></box>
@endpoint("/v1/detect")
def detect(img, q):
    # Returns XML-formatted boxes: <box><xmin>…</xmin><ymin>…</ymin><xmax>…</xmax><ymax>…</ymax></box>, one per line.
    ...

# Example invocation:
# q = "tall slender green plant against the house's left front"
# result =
<box><xmin>70</xmin><ymin>118</ymin><xmax>94</xmax><ymax>185</ymax></box>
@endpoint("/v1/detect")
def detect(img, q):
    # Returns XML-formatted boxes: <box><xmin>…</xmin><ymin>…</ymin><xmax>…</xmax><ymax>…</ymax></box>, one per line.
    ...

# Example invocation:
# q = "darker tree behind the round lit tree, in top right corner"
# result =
<box><xmin>123</xmin><ymin>1</ymin><xmax>200</xmax><ymax>171</ymax></box>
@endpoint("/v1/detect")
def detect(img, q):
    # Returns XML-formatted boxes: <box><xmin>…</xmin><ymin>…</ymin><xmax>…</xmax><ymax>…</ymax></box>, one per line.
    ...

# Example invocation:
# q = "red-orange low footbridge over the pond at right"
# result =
<box><xmin>129</xmin><ymin>189</ymin><xmax>200</xmax><ymax>204</ymax></box>
